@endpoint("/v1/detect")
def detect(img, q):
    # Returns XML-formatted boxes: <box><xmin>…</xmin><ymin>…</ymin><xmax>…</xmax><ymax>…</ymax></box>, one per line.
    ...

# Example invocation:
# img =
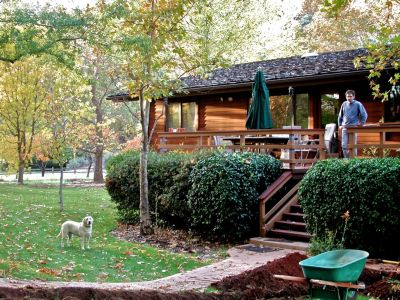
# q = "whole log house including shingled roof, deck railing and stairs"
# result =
<box><xmin>108</xmin><ymin>49</ymin><xmax>400</xmax><ymax>246</ymax></box>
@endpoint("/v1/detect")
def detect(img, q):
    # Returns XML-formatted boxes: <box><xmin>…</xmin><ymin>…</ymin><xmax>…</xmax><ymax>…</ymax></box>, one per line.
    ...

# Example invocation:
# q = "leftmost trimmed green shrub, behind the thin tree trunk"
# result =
<box><xmin>106</xmin><ymin>151</ymin><xmax>212</xmax><ymax>228</ymax></box>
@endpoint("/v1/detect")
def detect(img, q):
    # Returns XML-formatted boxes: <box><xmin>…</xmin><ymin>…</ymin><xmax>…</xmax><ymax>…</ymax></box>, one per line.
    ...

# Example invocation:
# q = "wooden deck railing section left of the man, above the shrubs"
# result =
<box><xmin>158</xmin><ymin>129</ymin><xmax>326</xmax><ymax>169</ymax></box>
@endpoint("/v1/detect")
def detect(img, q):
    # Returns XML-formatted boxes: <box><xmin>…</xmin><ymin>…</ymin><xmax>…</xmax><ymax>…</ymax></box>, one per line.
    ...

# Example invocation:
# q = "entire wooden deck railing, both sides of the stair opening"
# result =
<box><xmin>158</xmin><ymin>124</ymin><xmax>400</xmax><ymax>169</ymax></box>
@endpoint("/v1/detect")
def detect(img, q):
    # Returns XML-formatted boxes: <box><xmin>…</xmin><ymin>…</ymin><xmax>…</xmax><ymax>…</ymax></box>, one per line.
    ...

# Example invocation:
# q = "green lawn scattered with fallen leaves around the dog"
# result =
<box><xmin>0</xmin><ymin>184</ymin><xmax>212</xmax><ymax>282</ymax></box>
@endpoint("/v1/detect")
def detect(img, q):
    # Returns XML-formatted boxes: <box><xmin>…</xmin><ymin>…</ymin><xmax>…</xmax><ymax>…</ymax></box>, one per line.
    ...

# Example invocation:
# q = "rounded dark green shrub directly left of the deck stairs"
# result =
<box><xmin>189</xmin><ymin>152</ymin><xmax>281</xmax><ymax>241</ymax></box>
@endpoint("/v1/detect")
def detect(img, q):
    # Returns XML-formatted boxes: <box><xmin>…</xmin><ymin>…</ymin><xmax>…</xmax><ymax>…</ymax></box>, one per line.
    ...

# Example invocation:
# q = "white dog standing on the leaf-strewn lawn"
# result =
<box><xmin>57</xmin><ymin>216</ymin><xmax>93</xmax><ymax>250</ymax></box>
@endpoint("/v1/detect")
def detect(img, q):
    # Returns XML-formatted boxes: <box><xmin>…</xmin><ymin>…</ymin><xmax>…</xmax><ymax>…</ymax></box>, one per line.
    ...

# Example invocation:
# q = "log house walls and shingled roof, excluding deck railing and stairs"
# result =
<box><xmin>109</xmin><ymin>49</ymin><xmax>400</xmax><ymax>154</ymax></box>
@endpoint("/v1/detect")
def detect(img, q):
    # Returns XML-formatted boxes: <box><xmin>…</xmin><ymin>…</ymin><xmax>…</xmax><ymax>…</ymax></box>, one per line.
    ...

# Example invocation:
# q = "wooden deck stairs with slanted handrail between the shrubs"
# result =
<box><xmin>250</xmin><ymin>171</ymin><xmax>311</xmax><ymax>250</ymax></box>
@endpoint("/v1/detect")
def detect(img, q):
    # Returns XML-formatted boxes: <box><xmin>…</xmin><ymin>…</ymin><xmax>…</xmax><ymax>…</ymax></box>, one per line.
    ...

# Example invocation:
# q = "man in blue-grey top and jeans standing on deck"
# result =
<box><xmin>338</xmin><ymin>90</ymin><xmax>368</xmax><ymax>159</ymax></box>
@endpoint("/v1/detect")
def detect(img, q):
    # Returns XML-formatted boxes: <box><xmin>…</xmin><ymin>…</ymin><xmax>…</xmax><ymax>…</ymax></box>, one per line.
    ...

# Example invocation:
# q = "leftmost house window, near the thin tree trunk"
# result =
<box><xmin>167</xmin><ymin>102</ymin><xmax>197</xmax><ymax>131</ymax></box>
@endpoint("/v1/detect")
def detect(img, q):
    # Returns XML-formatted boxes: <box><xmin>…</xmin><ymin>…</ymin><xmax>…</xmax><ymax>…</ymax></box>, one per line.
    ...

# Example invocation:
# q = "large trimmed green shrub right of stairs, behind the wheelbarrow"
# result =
<box><xmin>299</xmin><ymin>158</ymin><xmax>400</xmax><ymax>259</ymax></box>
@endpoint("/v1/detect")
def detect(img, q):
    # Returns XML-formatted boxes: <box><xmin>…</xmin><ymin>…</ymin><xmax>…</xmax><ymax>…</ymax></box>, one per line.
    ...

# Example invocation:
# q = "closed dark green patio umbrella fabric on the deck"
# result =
<box><xmin>246</xmin><ymin>71</ymin><xmax>272</xmax><ymax>129</ymax></box>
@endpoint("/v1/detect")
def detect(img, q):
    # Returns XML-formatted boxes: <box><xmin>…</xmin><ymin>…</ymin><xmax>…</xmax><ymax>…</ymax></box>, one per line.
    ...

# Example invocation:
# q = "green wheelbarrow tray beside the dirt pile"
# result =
<box><xmin>299</xmin><ymin>249</ymin><xmax>369</xmax><ymax>282</ymax></box>
